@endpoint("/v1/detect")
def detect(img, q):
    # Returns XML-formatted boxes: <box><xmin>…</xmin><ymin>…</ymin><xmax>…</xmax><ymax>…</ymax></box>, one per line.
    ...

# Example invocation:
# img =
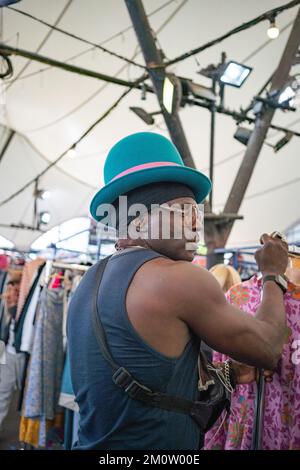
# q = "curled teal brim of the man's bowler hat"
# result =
<box><xmin>90</xmin><ymin>166</ymin><xmax>211</xmax><ymax>222</ymax></box>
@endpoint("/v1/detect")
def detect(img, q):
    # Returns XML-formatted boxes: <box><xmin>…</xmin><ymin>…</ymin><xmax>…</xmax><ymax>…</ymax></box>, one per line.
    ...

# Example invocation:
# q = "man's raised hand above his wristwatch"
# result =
<box><xmin>255</xmin><ymin>233</ymin><xmax>288</xmax><ymax>275</ymax></box>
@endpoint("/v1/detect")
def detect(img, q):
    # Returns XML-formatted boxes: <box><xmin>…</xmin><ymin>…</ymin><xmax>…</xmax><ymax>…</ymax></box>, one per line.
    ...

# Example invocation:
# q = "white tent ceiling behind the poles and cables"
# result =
<box><xmin>0</xmin><ymin>0</ymin><xmax>300</xmax><ymax>247</ymax></box>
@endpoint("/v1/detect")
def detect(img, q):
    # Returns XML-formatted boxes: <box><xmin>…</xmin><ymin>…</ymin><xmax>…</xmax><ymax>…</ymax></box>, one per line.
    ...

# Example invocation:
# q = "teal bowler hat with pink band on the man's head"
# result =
<box><xmin>90</xmin><ymin>132</ymin><xmax>211</xmax><ymax>221</ymax></box>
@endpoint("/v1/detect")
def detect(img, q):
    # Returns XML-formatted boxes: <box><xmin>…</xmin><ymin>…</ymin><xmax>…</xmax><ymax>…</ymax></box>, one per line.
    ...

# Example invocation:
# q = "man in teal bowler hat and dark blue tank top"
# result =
<box><xmin>68</xmin><ymin>132</ymin><xmax>288</xmax><ymax>450</ymax></box>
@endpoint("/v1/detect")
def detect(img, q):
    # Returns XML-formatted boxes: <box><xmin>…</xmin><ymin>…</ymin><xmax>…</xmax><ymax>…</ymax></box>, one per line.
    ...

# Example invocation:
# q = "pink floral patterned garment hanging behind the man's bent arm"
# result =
<box><xmin>205</xmin><ymin>276</ymin><xmax>300</xmax><ymax>450</ymax></box>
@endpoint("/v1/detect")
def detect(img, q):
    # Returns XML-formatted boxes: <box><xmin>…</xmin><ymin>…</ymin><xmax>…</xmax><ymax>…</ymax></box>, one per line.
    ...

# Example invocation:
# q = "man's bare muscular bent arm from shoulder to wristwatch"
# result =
<box><xmin>167</xmin><ymin>262</ymin><xmax>285</xmax><ymax>369</ymax></box>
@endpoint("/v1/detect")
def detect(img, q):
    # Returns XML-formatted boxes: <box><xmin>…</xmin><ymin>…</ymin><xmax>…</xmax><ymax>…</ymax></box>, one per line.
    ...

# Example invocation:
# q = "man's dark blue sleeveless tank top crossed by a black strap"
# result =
<box><xmin>68</xmin><ymin>249</ymin><xmax>200</xmax><ymax>450</ymax></box>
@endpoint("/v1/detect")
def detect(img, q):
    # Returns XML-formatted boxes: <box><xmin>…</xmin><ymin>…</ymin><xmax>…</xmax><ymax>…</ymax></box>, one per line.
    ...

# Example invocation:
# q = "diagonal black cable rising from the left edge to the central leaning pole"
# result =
<box><xmin>0</xmin><ymin>83</ymin><xmax>135</xmax><ymax>207</ymax></box>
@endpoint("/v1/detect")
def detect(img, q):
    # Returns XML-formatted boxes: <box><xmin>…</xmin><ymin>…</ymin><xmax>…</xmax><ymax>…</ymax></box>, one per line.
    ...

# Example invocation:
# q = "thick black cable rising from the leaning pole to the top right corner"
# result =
<box><xmin>164</xmin><ymin>0</ymin><xmax>300</xmax><ymax>67</ymax></box>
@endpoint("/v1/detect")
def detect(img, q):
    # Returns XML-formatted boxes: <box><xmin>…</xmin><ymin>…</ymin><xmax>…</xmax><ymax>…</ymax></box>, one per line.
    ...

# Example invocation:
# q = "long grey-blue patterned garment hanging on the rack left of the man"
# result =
<box><xmin>22</xmin><ymin>288</ymin><xmax>64</xmax><ymax>446</ymax></box>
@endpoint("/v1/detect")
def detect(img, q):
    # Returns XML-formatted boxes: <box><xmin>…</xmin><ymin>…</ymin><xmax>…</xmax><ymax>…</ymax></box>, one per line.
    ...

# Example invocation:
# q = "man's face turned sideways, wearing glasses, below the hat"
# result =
<box><xmin>129</xmin><ymin>197</ymin><xmax>203</xmax><ymax>261</ymax></box>
